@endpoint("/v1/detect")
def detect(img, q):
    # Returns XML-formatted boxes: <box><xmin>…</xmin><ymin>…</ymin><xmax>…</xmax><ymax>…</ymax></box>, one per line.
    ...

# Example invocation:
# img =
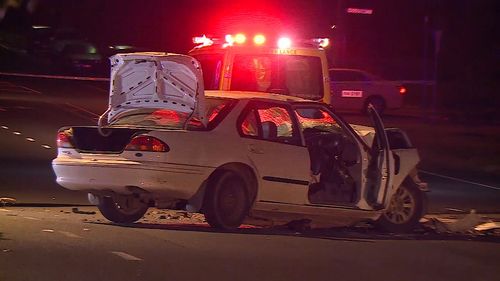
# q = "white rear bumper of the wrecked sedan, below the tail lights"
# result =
<box><xmin>52</xmin><ymin>158</ymin><xmax>214</xmax><ymax>199</ymax></box>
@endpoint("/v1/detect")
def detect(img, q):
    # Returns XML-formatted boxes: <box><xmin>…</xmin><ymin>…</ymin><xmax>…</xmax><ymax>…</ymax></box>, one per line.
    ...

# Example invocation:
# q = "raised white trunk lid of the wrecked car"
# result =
<box><xmin>105</xmin><ymin>53</ymin><xmax>207</xmax><ymax>126</ymax></box>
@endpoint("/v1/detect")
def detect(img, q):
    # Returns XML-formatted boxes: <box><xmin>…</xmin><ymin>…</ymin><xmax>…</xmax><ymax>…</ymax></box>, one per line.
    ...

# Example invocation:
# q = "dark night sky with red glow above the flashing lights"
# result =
<box><xmin>0</xmin><ymin>0</ymin><xmax>500</xmax><ymax>112</ymax></box>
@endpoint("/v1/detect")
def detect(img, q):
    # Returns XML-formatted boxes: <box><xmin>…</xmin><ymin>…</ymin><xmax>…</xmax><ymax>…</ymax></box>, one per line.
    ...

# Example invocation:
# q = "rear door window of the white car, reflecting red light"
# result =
<box><xmin>239</xmin><ymin>101</ymin><xmax>300</xmax><ymax>145</ymax></box>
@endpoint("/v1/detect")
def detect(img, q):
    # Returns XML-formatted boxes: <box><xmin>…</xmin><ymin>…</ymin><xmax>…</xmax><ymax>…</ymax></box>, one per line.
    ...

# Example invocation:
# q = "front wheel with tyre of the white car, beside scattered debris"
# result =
<box><xmin>377</xmin><ymin>182</ymin><xmax>425</xmax><ymax>232</ymax></box>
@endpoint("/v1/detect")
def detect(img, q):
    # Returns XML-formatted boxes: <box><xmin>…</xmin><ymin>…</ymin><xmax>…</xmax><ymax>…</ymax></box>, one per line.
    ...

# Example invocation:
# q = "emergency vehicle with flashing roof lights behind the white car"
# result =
<box><xmin>189</xmin><ymin>34</ymin><xmax>331</xmax><ymax>104</ymax></box>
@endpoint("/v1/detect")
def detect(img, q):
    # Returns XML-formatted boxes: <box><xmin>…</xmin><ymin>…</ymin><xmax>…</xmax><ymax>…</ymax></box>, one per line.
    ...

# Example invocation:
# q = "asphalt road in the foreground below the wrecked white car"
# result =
<box><xmin>0</xmin><ymin>207</ymin><xmax>500</xmax><ymax>281</ymax></box>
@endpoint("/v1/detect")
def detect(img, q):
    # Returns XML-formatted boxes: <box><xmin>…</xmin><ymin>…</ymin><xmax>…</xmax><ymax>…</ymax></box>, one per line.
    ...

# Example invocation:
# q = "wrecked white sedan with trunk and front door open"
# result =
<box><xmin>52</xmin><ymin>53</ymin><xmax>427</xmax><ymax>231</ymax></box>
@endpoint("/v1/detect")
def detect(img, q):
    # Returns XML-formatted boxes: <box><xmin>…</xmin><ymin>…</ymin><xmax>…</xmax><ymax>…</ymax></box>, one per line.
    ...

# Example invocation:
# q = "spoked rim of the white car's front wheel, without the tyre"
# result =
<box><xmin>384</xmin><ymin>186</ymin><xmax>416</xmax><ymax>224</ymax></box>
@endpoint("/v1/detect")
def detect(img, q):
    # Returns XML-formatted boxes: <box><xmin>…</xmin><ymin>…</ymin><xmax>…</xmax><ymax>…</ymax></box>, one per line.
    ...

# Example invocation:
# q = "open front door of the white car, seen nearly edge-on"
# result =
<box><xmin>366</xmin><ymin>104</ymin><xmax>395</xmax><ymax>209</ymax></box>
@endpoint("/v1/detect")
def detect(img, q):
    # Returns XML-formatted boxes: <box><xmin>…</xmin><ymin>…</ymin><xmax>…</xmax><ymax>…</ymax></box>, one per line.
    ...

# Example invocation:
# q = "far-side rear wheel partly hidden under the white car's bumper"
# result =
<box><xmin>97</xmin><ymin>196</ymin><xmax>148</xmax><ymax>223</ymax></box>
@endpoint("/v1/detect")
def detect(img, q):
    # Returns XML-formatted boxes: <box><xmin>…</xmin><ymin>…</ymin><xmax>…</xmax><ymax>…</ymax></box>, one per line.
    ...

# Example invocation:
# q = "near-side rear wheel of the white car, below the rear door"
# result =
<box><xmin>203</xmin><ymin>171</ymin><xmax>249</xmax><ymax>229</ymax></box>
